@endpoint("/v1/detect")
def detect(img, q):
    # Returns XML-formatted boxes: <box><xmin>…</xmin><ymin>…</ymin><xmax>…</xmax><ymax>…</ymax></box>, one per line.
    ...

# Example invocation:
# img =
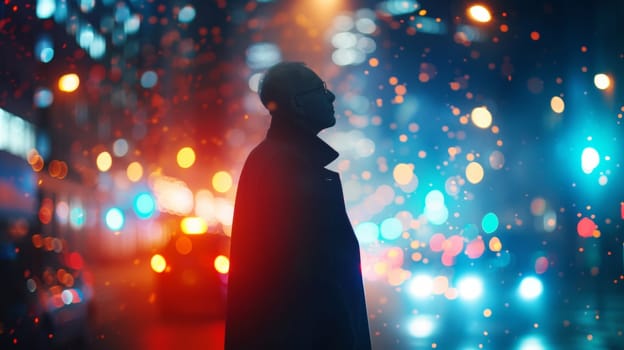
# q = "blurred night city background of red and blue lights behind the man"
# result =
<box><xmin>0</xmin><ymin>0</ymin><xmax>624</xmax><ymax>350</ymax></box>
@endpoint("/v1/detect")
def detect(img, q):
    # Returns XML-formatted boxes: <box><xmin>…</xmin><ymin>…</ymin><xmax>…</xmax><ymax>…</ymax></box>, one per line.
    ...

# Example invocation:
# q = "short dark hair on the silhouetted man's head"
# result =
<box><xmin>258</xmin><ymin>61</ymin><xmax>313</xmax><ymax>113</ymax></box>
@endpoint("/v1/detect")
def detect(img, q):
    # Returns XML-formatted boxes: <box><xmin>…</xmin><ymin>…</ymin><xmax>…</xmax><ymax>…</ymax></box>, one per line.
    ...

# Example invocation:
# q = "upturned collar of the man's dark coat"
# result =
<box><xmin>267</xmin><ymin>117</ymin><xmax>339</xmax><ymax>167</ymax></box>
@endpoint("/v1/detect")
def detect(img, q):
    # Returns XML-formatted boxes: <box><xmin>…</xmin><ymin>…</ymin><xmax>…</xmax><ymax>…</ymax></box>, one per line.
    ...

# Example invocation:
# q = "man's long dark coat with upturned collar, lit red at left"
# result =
<box><xmin>225</xmin><ymin>121</ymin><xmax>371</xmax><ymax>350</ymax></box>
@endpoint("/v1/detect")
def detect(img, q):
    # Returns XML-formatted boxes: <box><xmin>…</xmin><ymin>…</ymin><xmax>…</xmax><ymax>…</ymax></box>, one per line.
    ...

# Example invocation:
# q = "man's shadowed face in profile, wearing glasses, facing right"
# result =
<box><xmin>293</xmin><ymin>70</ymin><xmax>336</xmax><ymax>131</ymax></box>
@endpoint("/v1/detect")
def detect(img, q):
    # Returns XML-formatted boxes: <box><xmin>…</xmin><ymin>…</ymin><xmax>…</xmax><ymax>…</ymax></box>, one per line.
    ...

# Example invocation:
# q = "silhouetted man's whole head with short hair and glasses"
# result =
<box><xmin>259</xmin><ymin>62</ymin><xmax>336</xmax><ymax>133</ymax></box>
